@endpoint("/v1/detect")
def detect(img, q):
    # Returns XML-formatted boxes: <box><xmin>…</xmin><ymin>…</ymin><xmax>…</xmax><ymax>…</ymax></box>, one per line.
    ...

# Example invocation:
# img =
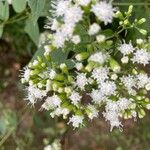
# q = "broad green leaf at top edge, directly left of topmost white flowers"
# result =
<box><xmin>28</xmin><ymin>0</ymin><xmax>46</xmax><ymax>22</ymax></box>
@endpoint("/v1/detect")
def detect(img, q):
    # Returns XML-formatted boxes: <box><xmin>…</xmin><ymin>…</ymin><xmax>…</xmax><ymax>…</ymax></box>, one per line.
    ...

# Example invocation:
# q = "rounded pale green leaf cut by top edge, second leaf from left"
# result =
<box><xmin>12</xmin><ymin>0</ymin><xmax>26</xmax><ymax>13</ymax></box>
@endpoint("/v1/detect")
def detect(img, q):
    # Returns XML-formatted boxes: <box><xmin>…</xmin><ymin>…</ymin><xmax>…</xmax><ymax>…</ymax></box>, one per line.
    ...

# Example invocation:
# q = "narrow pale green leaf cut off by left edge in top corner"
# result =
<box><xmin>0</xmin><ymin>1</ymin><xmax>9</xmax><ymax>21</ymax></box>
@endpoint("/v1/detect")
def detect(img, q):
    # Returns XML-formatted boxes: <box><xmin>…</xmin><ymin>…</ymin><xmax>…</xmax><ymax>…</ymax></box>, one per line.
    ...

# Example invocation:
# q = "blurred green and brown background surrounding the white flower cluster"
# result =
<box><xmin>0</xmin><ymin>0</ymin><xmax>150</xmax><ymax>150</ymax></box>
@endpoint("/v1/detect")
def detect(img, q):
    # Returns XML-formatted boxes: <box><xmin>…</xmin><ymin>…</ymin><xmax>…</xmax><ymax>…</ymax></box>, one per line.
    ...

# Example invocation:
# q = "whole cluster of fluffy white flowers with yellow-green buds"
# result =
<box><xmin>22</xmin><ymin>0</ymin><xmax>150</xmax><ymax>130</ymax></box>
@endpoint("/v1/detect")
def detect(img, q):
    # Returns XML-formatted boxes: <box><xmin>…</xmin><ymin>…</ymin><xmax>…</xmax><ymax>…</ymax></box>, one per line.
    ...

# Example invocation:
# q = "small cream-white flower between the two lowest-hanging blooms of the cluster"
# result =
<box><xmin>87</xmin><ymin>105</ymin><xmax>98</xmax><ymax>120</ymax></box>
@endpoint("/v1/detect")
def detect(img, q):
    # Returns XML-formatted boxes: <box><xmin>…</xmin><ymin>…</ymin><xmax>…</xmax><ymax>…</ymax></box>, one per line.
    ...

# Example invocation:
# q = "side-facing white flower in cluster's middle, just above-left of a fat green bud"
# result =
<box><xmin>89</xmin><ymin>52</ymin><xmax>108</xmax><ymax>64</ymax></box>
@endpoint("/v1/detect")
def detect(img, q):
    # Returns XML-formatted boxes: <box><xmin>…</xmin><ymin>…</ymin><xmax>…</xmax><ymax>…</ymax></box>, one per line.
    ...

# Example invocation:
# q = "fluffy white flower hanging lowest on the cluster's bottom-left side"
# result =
<box><xmin>68</xmin><ymin>115</ymin><xmax>84</xmax><ymax>128</ymax></box>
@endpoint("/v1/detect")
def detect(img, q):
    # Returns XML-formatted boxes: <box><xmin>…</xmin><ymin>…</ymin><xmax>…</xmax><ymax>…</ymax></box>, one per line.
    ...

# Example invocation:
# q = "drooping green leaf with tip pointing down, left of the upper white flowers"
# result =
<box><xmin>25</xmin><ymin>18</ymin><xmax>40</xmax><ymax>45</ymax></box>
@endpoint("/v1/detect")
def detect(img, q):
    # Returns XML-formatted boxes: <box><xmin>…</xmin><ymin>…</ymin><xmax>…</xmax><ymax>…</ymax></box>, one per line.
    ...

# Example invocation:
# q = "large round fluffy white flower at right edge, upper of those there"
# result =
<box><xmin>132</xmin><ymin>49</ymin><xmax>150</xmax><ymax>66</ymax></box>
